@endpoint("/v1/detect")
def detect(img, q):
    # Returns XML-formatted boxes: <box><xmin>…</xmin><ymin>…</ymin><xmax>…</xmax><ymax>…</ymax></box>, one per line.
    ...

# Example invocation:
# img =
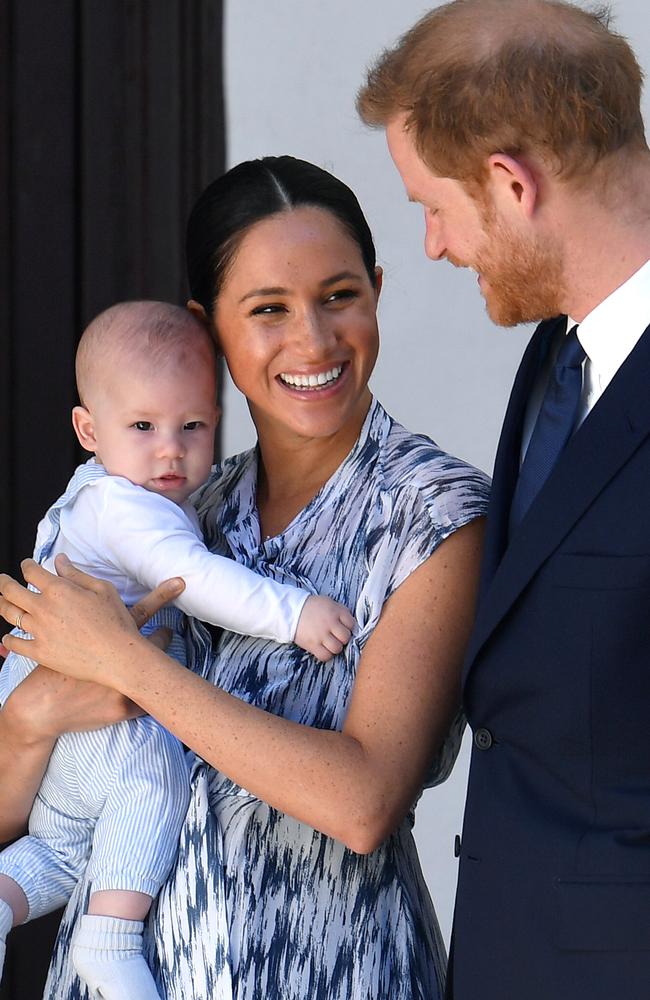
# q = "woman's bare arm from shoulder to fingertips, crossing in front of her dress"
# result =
<box><xmin>0</xmin><ymin>522</ymin><xmax>482</xmax><ymax>852</ymax></box>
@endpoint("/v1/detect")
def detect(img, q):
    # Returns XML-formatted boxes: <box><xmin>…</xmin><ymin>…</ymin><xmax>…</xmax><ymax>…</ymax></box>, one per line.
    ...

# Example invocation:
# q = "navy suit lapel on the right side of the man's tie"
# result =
<box><xmin>465</xmin><ymin>327</ymin><xmax>650</xmax><ymax>673</ymax></box>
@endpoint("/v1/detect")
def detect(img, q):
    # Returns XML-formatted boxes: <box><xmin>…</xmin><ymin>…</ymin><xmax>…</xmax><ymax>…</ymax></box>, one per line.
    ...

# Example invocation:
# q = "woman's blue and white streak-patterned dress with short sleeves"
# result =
<box><xmin>45</xmin><ymin>401</ymin><xmax>488</xmax><ymax>1000</ymax></box>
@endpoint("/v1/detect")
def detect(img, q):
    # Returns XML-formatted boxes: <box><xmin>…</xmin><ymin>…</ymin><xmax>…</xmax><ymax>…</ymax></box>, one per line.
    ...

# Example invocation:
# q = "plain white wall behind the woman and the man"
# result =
<box><xmin>224</xmin><ymin>0</ymin><xmax>650</xmax><ymax>938</ymax></box>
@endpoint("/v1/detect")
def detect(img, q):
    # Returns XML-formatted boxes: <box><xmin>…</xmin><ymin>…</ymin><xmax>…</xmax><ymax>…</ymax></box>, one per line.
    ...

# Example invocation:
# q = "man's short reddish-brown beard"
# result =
<box><xmin>452</xmin><ymin>210</ymin><xmax>565</xmax><ymax>326</ymax></box>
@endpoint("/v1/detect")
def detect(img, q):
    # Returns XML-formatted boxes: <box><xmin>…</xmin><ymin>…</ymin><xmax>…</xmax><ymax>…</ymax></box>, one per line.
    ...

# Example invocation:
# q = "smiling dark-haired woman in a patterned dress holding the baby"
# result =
<box><xmin>0</xmin><ymin>157</ymin><xmax>487</xmax><ymax>1000</ymax></box>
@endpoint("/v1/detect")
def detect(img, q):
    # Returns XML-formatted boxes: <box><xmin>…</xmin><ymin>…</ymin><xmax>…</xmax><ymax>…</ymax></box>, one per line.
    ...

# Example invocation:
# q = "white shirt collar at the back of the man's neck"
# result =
<box><xmin>567</xmin><ymin>261</ymin><xmax>650</xmax><ymax>383</ymax></box>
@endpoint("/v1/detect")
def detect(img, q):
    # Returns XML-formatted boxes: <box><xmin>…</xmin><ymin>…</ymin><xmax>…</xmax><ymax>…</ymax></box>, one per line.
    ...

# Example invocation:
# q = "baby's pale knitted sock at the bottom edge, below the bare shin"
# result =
<box><xmin>72</xmin><ymin>914</ymin><xmax>160</xmax><ymax>1000</ymax></box>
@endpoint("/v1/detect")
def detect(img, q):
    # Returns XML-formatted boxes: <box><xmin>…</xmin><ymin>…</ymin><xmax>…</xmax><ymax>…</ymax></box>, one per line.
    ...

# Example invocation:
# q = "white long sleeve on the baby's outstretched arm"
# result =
<box><xmin>91</xmin><ymin>477</ymin><xmax>309</xmax><ymax>642</ymax></box>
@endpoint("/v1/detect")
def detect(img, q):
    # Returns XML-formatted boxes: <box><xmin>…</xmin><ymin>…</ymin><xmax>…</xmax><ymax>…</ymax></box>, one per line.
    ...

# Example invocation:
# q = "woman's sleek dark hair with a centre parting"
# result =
<box><xmin>186</xmin><ymin>156</ymin><xmax>376</xmax><ymax>315</ymax></box>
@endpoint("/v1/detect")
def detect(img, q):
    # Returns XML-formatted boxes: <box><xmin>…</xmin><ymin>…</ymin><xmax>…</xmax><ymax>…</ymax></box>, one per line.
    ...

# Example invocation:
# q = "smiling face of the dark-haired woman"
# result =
<box><xmin>214</xmin><ymin>207</ymin><xmax>381</xmax><ymax>446</ymax></box>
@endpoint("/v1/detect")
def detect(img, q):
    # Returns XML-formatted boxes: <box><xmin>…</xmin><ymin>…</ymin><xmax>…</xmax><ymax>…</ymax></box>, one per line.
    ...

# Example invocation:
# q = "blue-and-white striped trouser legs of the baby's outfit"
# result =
<box><xmin>0</xmin><ymin>654</ymin><xmax>189</xmax><ymax>920</ymax></box>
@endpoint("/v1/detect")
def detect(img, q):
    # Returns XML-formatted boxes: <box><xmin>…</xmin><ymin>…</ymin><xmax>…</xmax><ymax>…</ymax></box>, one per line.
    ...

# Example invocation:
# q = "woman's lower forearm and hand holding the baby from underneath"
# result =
<box><xmin>0</xmin><ymin>585</ymin><xmax>180</xmax><ymax>844</ymax></box>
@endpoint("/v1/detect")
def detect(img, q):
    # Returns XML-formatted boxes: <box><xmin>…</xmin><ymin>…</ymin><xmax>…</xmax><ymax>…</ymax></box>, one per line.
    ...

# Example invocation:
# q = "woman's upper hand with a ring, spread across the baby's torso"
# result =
<box><xmin>0</xmin><ymin>555</ymin><xmax>184</xmax><ymax>688</ymax></box>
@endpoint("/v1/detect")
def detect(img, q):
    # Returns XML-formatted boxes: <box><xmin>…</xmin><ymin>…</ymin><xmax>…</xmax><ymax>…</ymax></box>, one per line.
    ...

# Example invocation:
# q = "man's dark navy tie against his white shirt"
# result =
<box><xmin>510</xmin><ymin>326</ymin><xmax>586</xmax><ymax>534</ymax></box>
